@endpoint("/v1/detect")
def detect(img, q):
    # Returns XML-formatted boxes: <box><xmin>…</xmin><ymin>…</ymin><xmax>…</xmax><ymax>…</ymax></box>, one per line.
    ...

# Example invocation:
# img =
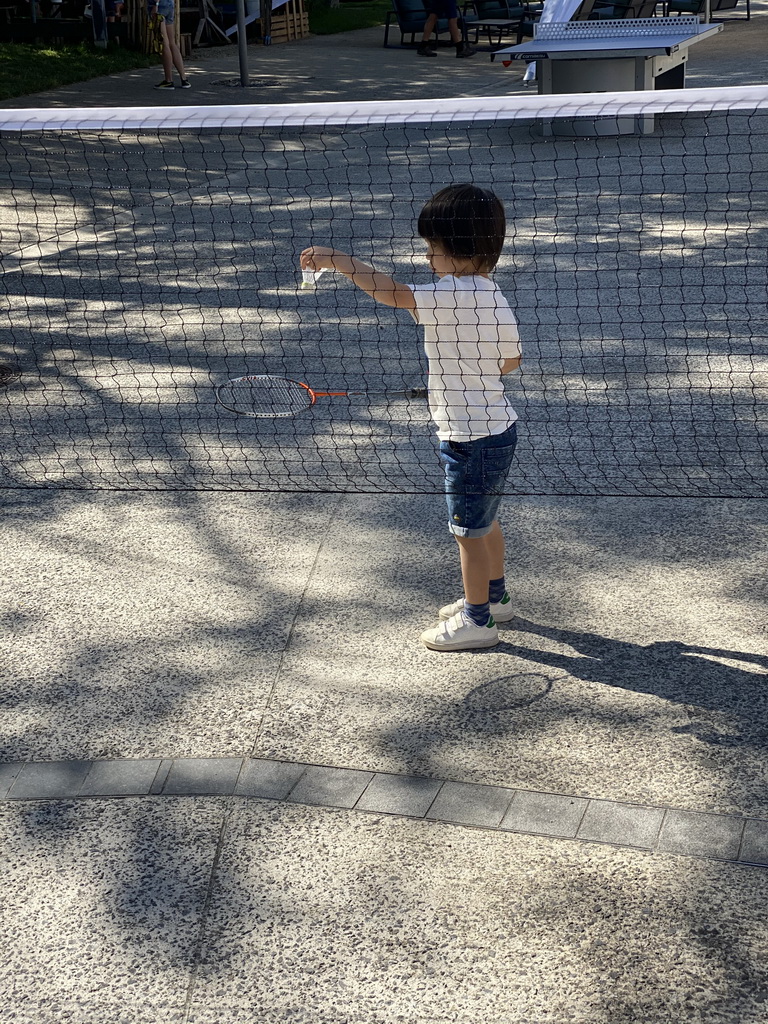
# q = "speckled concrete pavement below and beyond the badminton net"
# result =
<box><xmin>0</xmin><ymin>12</ymin><xmax>768</xmax><ymax>1024</ymax></box>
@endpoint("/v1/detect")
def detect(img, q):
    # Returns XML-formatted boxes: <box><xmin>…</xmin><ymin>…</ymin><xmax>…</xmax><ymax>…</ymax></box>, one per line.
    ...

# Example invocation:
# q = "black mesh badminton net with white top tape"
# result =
<box><xmin>0</xmin><ymin>88</ymin><xmax>768</xmax><ymax>498</ymax></box>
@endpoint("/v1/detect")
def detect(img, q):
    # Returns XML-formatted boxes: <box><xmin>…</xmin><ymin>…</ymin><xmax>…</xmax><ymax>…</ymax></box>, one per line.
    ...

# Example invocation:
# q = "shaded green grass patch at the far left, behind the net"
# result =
<box><xmin>0</xmin><ymin>43</ymin><xmax>160</xmax><ymax>99</ymax></box>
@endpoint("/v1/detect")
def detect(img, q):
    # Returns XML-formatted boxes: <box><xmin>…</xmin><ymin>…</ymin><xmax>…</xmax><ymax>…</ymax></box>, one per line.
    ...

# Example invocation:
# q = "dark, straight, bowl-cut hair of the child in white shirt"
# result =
<box><xmin>418</xmin><ymin>185</ymin><xmax>507</xmax><ymax>272</ymax></box>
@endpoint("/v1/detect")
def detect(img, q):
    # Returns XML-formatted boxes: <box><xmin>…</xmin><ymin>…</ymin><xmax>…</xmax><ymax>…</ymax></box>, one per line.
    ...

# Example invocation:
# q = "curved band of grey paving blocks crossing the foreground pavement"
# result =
<box><xmin>0</xmin><ymin>758</ymin><xmax>768</xmax><ymax>867</ymax></box>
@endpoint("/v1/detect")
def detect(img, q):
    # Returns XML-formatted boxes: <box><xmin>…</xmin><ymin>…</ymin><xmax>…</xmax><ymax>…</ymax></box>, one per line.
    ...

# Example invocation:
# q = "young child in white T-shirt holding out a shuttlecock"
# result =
<box><xmin>301</xmin><ymin>184</ymin><xmax>520</xmax><ymax>650</ymax></box>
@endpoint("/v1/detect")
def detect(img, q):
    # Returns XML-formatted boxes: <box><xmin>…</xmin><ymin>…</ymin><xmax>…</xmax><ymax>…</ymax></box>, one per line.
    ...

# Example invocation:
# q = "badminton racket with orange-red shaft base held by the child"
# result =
<box><xmin>216</xmin><ymin>374</ymin><xmax>427</xmax><ymax>418</ymax></box>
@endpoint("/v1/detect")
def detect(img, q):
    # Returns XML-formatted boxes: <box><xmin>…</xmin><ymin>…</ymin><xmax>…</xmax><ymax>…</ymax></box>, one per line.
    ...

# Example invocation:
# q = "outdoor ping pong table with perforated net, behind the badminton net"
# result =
<box><xmin>490</xmin><ymin>14</ymin><xmax>723</xmax><ymax>135</ymax></box>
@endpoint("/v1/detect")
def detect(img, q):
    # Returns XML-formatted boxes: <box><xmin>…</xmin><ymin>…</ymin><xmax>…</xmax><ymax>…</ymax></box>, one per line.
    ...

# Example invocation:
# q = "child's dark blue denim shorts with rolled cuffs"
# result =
<box><xmin>440</xmin><ymin>423</ymin><xmax>517</xmax><ymax>537</ymax></box>
